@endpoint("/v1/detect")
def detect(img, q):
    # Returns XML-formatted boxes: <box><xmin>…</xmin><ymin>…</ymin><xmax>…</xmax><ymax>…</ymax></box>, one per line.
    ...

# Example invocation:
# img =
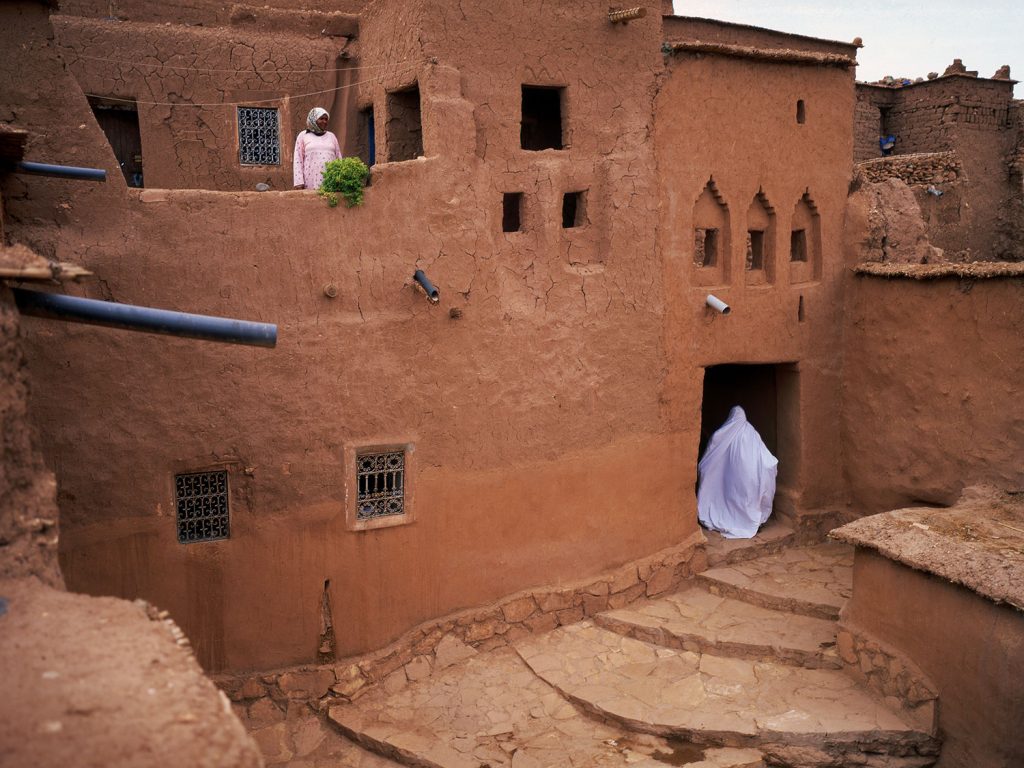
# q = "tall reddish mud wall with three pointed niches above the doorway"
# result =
<box><xmin>655</xmin><ymin>34</ymin><xmax>854</xmax><ymax>518</ymax></box>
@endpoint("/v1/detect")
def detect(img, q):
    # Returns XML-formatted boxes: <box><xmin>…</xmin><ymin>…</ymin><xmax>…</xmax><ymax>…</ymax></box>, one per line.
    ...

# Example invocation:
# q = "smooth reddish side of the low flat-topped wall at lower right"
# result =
<box><xmin>845</xmin><ymin>548</ymin><xmax>1024</xmax><ymax>768</ymax></box>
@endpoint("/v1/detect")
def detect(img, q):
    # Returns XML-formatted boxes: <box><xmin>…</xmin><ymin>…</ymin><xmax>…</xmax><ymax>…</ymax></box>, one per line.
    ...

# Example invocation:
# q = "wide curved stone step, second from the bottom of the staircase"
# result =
<box><xmin>516</xmin><ymin>622</ymin><xmax>938</xmax><ymax>768</ymax></box>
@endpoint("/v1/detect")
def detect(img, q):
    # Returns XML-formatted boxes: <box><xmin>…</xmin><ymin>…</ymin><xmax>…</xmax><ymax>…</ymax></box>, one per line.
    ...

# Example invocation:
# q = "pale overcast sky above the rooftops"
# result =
<box><xmin>675</xmin><ymin>0</ymin><xmax>1024</xmax><ymax>98</ymax></box>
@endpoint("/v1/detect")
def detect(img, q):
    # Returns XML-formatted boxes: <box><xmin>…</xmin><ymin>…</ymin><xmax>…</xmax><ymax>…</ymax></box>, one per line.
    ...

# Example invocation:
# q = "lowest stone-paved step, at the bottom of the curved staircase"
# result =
<box><xmin>328</xmin><ymin>648</ymin><xmax>763</xmax><ymax>768</ymax></box>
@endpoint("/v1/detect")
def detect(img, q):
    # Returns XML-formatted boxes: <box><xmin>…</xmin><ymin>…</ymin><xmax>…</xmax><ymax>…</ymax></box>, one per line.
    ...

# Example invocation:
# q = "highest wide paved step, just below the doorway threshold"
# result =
<box><xmin>697</xmin><ymin>544</ymin><xmax>853</xmax><ymax>621</ymax></box>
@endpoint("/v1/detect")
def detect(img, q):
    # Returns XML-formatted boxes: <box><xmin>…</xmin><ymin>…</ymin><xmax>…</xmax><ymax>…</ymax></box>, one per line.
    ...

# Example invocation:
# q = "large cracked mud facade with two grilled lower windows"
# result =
<box><xmin>3</xmin><ymin>2</ymin><xmax>700</xmax><ymax>670</ymax></box>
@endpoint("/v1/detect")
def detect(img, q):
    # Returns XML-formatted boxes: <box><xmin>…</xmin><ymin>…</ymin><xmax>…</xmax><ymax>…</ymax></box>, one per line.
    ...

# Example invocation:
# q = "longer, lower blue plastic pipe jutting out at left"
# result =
<box><xmin>13</xmin><ymin>288</ymin><xmax>278</xmax><ymax>347</ymax></box>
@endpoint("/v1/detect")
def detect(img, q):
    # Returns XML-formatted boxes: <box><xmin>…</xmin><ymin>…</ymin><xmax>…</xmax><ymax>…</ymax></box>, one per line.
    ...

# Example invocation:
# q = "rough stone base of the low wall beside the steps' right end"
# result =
<box><xmin>836</xmin><ymin>622</ymin><xmax>939</xmax><ymax>735</ymax></box>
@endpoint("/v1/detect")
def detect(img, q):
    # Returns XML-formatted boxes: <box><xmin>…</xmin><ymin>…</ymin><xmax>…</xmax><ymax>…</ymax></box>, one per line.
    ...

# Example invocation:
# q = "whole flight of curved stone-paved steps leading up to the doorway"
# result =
<box><xmin>330</xmin><ymin>523</ymin><xmax>939</xmax><ymax>768</ymax></box>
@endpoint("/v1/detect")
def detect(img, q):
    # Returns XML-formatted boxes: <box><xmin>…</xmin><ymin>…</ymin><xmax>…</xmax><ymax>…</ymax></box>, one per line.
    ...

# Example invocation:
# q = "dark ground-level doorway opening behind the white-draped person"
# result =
<box><xmin>698</xmin><ymin>362</ymin><xmax>800</xmax><ymax>488</ymax></box>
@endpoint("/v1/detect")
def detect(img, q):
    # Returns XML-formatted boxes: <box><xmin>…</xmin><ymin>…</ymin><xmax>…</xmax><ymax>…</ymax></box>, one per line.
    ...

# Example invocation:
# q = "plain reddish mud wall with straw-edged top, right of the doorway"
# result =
<box><xmin>842</xmin><ymin>276</ymin><xmax>1024</xmax><ymax>514</ymax></box>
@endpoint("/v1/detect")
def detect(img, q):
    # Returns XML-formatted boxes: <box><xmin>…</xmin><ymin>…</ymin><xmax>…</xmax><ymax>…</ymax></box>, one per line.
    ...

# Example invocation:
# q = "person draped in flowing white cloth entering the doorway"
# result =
<box><xmin>697</xmin><ymin>406</ymin><xmax>778</xmax><ymax>539</ymax></box>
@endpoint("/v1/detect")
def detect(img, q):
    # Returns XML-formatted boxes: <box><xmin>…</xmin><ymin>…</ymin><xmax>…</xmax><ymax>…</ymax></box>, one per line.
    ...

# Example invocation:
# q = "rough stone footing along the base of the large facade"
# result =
<box><xmin>214</xmin><ymin>531</ymin><xmax>708</xmax><ymax>724</ymax></box>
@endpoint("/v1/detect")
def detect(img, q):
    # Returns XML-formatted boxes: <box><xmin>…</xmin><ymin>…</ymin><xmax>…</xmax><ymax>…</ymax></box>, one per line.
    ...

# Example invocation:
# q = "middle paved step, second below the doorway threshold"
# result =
<box><xmin>594</xmin><ymin>587</ymin><xmax>843</xmax><ymax>669</ymax></box>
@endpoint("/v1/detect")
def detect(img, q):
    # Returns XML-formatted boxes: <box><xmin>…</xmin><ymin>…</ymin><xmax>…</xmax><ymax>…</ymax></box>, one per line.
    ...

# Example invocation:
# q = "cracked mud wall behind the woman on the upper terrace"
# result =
<box><xmin>53</xmin><ymin>13</ymin><xmax>360</xmax><ymax>189</ymax></box>
